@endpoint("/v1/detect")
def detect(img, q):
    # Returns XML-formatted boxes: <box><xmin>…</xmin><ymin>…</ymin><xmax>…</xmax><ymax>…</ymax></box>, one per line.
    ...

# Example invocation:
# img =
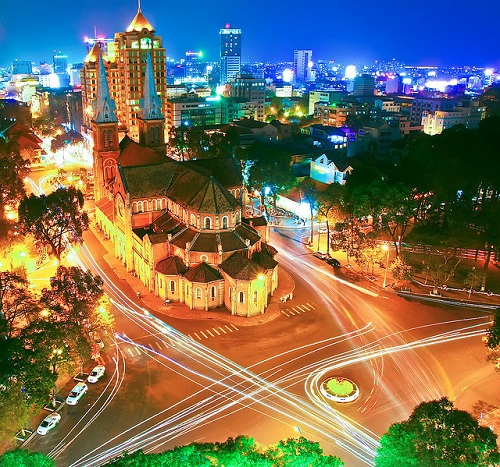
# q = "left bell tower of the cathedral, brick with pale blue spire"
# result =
<box><xmin>92</xmin><ymin>53</ymin><xmax>120</xmax><ymax>201</ymax></box>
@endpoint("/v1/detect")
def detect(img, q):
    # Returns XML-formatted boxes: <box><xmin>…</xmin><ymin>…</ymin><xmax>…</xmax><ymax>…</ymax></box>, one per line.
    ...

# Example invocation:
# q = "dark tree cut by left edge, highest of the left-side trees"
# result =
<box><xmin>0</xmin><ymin>137</ymin><xmax>29</xmax><ymax>220</ymax></box>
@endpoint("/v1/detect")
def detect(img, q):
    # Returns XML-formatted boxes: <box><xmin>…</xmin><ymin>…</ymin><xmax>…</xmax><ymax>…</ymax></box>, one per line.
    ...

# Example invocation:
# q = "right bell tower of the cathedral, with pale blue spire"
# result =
<box><xmin>137</xmin><ymin>51</ymin><xmax>165</xmax><ymax>154</ymax></box>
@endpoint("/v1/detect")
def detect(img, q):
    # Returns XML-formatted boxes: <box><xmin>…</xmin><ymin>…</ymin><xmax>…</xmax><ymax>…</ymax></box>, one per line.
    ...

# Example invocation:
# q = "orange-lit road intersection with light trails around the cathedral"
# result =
<box><xmin>20</xmin><ymin>176</ymin><xmax>500</xmax><ymax>466</ymax></box>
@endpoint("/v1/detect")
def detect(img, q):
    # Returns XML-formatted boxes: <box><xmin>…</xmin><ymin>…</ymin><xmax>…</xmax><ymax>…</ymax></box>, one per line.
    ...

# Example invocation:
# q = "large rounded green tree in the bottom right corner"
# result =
<box><xmin>375</xmin><ymin>397</ymin><xmax>500</xmax><ymax>467</ymax></box>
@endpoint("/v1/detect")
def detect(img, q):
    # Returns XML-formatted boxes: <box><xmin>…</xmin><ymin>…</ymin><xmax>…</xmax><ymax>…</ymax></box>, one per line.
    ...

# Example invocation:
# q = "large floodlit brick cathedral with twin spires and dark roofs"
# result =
<box><xmin>87</xmin><ymin>10</ymin><xmax>278</xmax><ymax>317</ymax></box>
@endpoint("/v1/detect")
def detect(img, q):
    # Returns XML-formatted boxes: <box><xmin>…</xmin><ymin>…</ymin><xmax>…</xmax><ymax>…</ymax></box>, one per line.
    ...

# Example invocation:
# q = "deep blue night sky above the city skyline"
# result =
<box><xmin>0</xmin><ymin>0</ymin><xmax>500</xmax><ymax>69</ymax></box>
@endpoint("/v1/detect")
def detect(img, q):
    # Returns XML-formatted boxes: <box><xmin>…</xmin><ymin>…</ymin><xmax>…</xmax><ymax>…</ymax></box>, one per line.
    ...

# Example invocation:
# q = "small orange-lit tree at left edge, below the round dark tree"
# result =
<box><xmin>0</xmin><ymin>271</ymin><xmax>40</xmax><ymax>337</ymax></box>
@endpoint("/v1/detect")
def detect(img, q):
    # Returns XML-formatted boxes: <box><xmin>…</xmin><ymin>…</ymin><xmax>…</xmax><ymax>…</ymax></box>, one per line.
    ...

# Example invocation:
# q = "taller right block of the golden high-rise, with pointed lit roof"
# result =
<box><xmin>109</xmin><ymin>8</ymin><xmax>167</xmax><ymax>141</ymax></box>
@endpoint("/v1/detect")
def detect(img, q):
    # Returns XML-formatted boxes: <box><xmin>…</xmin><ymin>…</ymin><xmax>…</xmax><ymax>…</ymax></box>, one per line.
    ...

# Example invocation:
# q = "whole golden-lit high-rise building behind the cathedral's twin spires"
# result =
<box><xmin>82</xmin><ymin>8</ymin><xmax>167</xmax><ymax>141</ymax></box>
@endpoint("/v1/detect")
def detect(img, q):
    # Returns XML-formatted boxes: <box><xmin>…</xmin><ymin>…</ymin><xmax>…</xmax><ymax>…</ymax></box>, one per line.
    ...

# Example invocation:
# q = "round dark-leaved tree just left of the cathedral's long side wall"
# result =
<box><xmin>19</xmin><ymin>187</ymin><xmax>89</xmax><ymax>263</ymax></box>
